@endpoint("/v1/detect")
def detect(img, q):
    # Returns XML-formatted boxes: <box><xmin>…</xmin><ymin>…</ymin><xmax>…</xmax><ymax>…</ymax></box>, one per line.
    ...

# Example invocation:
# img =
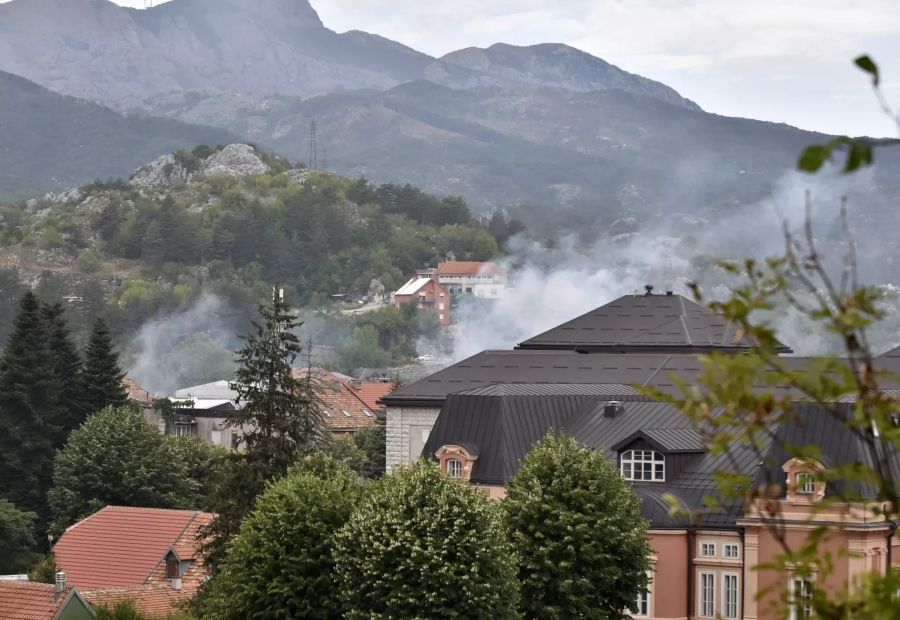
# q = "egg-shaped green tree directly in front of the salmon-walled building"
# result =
<box><xmin>503</xmin><ymin>435</ymin><xmax>650</xmax><ymax>619</ymax></box>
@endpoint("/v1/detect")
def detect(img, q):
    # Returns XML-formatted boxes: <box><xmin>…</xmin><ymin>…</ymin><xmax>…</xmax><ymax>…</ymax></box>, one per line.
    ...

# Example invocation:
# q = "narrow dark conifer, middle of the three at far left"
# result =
<box><xmin>41</xmin><ymin>302</ymin><xmax>88</xmax><ymax>440</ymax></box>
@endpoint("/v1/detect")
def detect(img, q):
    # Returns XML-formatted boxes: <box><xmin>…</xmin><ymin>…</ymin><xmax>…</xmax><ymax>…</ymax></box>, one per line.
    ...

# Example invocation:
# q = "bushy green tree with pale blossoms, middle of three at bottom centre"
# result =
<box><xmin>335</xmin><ymin>463</ymin><xmax>518</xmax><ymax>618</ymax></box>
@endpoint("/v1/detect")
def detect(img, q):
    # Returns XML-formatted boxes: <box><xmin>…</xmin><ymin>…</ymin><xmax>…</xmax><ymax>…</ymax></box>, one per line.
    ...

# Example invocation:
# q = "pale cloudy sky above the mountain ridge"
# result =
<box><xmin>33</xmin><ymin>0</ymin><xmax>900</xmax><ymax>136</ymax></box>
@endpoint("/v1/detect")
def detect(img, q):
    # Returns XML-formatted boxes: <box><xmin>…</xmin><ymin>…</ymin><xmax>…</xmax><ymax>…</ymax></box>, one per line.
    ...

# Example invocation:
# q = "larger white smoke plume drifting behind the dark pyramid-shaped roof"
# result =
<box><xmin>452</xmin><ymin>169</ymin><xmax>900</xmax><ymax>360</ymax></box>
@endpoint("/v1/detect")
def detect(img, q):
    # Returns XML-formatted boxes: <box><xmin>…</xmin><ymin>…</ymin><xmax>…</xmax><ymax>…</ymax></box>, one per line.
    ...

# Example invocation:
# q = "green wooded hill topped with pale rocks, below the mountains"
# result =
<box><xmin>0</xmin><ymin>145</ymin><xmax>521</xmax><ymax>382</ymax></box>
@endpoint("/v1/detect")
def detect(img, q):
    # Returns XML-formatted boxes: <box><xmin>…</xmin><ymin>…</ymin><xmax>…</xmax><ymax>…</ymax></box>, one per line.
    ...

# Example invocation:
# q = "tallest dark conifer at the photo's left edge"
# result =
<box><xmin>0</xmin><ymin>292</ymin><xmax>61</xmax><ymax>533</ymax></box>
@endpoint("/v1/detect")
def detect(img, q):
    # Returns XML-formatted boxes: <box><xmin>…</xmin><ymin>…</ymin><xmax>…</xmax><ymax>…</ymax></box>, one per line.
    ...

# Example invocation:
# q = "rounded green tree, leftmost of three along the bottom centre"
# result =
<box><xmin>202</xmin><ymin>455</ymin><xmax>364</xmax><ymax>620</ymax></box>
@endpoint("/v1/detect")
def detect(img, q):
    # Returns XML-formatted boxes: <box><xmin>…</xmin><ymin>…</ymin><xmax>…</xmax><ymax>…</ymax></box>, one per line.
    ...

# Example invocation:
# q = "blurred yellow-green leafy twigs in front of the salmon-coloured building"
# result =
<box><xmin>653</xmin><ymin>196</ymin><xmax>900</xmax><ymax>620</ymax></box>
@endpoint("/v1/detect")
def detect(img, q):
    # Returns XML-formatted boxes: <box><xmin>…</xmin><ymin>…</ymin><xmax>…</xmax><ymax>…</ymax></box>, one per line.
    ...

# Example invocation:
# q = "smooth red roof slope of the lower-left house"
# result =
<box><xmin>53</xmin><ymin>506</ymin><xmax>212</xmax><ymax>590</ymax></box>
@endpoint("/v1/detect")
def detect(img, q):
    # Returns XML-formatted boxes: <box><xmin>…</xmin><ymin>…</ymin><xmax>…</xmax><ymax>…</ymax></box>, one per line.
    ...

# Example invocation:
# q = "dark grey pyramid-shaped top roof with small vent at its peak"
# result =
<box><xmin>516</xmin><ymin>291</ymin><xmax>791</xmax><ymax>353</ymax></box>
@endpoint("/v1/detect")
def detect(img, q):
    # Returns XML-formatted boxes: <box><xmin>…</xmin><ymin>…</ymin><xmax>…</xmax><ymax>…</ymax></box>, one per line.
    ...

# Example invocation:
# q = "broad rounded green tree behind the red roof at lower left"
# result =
<box><xmin>48</xmin><ymin>405</ymin><xmax>206</xmax><ymax>532</ymax></box>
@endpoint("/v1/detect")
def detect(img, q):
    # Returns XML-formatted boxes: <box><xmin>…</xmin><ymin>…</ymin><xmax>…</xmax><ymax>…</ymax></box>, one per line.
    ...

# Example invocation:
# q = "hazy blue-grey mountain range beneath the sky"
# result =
<box><xmin>0</xmin><ymin>0</ymin><xmax>900</xmax><ymax>229</ymax></box>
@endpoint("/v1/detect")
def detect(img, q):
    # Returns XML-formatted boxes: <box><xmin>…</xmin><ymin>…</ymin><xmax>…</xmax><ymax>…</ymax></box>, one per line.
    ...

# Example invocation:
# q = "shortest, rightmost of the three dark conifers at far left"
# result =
<box><xmin>82</xmin><ymin>319</ymin><xmax>128</xmax><ymax>414</ymax></box>
